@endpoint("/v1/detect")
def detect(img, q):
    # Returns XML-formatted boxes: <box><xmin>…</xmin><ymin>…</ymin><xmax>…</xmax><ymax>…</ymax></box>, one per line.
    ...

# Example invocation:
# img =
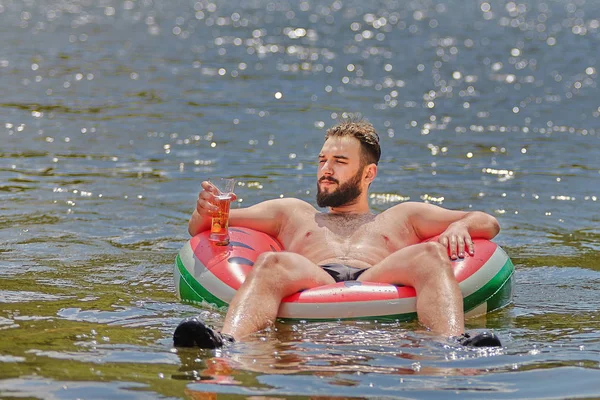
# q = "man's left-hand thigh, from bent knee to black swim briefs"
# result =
<box><xmin>253</xmin><ymin>251</ymin><xmax>335</xmax><ymax>293</ymax></box>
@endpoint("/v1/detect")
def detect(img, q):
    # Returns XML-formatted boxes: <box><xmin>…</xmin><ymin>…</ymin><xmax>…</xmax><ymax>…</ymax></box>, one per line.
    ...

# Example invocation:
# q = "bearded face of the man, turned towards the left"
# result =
<box><xmin>317</xmin><ymin>137</ymin><xmax>364</xmax><ymax>207</ymax></box>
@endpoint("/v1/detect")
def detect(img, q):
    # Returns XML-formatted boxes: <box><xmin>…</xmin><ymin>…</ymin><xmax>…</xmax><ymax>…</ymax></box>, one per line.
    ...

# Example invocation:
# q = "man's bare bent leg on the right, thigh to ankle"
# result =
<box><xmin>358</xmin><ymin>242</ymin><xmax>464</xmax><ymax>336</ymax></box>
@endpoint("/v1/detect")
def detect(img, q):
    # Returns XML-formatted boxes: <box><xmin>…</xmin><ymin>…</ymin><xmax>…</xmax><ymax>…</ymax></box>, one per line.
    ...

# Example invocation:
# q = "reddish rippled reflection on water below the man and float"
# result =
<box><xmin>176</xmin><ymin>322</ymin><xmax>504</xmax><ymax>385</ymax></box>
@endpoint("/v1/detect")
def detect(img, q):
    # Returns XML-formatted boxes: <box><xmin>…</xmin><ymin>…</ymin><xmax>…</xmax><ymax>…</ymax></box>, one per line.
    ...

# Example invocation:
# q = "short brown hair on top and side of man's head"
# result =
<box><xmin>325</xmin><ymin>118</ymin><xmax>381</xmax><ymax>165</ymax></box>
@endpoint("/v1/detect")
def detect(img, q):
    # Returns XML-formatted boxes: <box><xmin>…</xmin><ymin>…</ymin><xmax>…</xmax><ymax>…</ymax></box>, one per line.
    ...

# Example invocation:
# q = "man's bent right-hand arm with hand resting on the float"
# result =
<box><xmin>409</xmin><ymin>203</ymin><xmax>500</xmax><ymax>259</ymax></box>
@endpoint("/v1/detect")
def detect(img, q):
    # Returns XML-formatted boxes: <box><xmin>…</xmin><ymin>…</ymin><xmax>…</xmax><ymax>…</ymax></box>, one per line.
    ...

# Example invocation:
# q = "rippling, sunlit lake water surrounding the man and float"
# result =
<box><xmin>0</xmin><ymin>0</ymin><xmax>600</xmax><ymax>399</ymax></box>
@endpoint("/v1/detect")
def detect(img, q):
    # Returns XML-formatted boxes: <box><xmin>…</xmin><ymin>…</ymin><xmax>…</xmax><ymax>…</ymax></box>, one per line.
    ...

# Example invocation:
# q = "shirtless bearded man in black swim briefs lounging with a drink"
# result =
<box><xmin>174</xmin><ymin>121</ymin><xmax>500</xmax><ymax>348</ymax></box>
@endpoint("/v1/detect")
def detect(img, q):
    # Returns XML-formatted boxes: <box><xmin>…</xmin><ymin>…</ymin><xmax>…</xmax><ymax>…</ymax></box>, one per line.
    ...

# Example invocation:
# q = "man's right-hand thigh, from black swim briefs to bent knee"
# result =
<box><xmin>358</xmin><ymin>242</ymin><xmax>450</xmax><ymax>287</ymax></box>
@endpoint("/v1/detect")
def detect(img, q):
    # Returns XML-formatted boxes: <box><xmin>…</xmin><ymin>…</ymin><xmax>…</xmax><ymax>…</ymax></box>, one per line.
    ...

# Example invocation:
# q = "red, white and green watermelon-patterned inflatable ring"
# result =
<box><xmin>174</xmin><ymin>227</ymin><xmax>514</xmax><ymax>321</ymax></box>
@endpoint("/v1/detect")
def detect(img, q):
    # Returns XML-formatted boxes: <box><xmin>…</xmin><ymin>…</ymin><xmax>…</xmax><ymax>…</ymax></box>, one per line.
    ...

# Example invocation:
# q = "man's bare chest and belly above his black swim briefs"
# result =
<box><xmin>279</xmin><ymin>203</ymin><xmax>418</xmax><ymax>268</ymax></box>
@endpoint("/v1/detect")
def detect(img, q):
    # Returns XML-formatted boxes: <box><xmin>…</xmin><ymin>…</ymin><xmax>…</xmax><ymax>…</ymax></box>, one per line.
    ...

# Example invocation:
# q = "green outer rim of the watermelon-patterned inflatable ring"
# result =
<box><xmin>175</xmin><ymin>250</ymin><xmax>515</xmax><ymax>321</ymax></box>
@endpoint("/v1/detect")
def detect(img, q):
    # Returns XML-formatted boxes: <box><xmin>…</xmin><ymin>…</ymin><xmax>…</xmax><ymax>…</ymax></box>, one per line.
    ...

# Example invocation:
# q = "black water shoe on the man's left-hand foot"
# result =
<box><xmin>173</xmin><ymin>318</ymin><xmax>235</xmax><ymax>349</ymax></box>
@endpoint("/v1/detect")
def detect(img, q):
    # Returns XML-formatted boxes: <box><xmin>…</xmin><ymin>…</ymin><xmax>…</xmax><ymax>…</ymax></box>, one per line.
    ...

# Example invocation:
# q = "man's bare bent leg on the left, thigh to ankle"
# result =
<box><xmin>222</xmin><ymin>252</ymin><xmax>335</xmax><ymax>340</ymax></box>
